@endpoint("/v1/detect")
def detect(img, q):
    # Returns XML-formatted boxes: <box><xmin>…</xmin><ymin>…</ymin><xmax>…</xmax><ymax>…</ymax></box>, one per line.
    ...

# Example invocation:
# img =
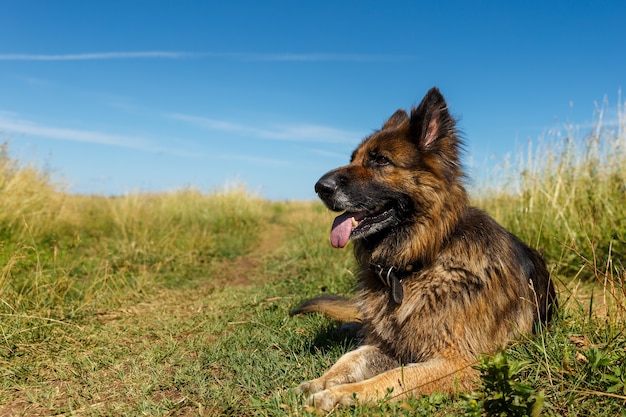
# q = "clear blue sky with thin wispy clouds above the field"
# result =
<box><xmin>0</xmin><ymin>0</ymin><xmax>626</xmax><ymax>199</ymax></box>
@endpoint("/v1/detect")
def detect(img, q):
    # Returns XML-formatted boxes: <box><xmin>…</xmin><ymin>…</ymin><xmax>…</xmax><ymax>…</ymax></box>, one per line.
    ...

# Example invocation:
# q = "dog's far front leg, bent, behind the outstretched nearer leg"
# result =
<box><xmin>298</xmin><ymin>345</ymin><xmax>398</xmax><ymax>394</ymax></box>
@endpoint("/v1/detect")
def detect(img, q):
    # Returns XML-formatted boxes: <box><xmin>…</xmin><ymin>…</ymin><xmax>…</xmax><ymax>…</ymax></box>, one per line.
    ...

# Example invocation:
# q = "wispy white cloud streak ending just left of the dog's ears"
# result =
<box><xmin>167</xmin><ymin>113</ymin><xmax>364</xmax><ymax>144</ymax></box>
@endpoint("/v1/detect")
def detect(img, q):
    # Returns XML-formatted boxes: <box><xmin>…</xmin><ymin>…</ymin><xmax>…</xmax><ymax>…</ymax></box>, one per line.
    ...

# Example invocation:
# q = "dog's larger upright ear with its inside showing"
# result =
<box><xmin>410</xmin><ymin>87</ymin><xmax>456</xmax><ymax>149</ymax></box>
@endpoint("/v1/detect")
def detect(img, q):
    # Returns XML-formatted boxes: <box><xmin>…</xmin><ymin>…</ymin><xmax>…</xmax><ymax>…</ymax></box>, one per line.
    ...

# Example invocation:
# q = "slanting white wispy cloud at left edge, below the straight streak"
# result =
<box><xmin>0</xmin><ymin>111</ymin><xmax>198</xmax><ymax>157</ymax></box>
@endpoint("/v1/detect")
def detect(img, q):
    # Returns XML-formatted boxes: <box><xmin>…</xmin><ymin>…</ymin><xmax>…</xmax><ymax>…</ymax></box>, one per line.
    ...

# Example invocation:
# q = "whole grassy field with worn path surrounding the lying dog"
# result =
<box><xmin>0</xmin><ymin>105</ymin><xmax>626</xmax><ymax>416</ymax></box>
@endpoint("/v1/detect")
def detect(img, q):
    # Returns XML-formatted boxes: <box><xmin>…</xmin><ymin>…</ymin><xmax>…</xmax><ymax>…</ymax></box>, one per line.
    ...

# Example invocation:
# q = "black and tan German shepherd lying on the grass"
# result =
<box><xmin>293</xmin><ymin>88</ymin><xmax>556</xmax><ymax>410</ymax></box>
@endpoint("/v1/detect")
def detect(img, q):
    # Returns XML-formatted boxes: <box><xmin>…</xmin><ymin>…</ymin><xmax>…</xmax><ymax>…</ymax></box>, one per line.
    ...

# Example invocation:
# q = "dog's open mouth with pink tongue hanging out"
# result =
<box><xmin>330</xmin><ymin>206</ymin><xmax>395</xmax><ymax>248</ymax></box>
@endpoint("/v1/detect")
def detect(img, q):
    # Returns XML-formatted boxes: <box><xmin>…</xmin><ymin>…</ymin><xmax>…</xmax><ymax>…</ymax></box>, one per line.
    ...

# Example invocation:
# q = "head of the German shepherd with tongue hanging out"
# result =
<box><xmin>315</xmin><ymin>88</ymin><xmax>462</xmax><ymax>248</ymax></box>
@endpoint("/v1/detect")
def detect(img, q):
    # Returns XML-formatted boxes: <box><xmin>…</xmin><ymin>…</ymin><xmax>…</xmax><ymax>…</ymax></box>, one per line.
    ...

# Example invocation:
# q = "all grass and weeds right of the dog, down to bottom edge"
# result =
<box><xmin>460</xmin><ymin>101</ymin><xmax>626</xmax><ymax>415</ymax></box>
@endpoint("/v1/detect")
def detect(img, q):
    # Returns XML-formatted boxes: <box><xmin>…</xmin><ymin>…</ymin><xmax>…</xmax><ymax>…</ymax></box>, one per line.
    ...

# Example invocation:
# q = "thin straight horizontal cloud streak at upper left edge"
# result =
<box><xmin>0</xmin><ymin>51</ymin><xmax>196</xmax><ymax>61</ymax></box>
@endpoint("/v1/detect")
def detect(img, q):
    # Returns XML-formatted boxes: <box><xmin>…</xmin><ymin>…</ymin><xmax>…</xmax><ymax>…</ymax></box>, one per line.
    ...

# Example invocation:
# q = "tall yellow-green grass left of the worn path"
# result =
<box><xmin>0</xmin><ymin>144</ymin><xmax>267</xmax><ymax>343</ymax></box>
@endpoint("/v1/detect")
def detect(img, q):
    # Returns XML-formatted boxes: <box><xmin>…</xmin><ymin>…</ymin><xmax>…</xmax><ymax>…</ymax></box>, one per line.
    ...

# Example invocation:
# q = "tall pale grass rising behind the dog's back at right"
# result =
<box><xmin>477</xmin><ymin>98</ymin><xmax>626</xmax><ymax>306</ymax></box>
